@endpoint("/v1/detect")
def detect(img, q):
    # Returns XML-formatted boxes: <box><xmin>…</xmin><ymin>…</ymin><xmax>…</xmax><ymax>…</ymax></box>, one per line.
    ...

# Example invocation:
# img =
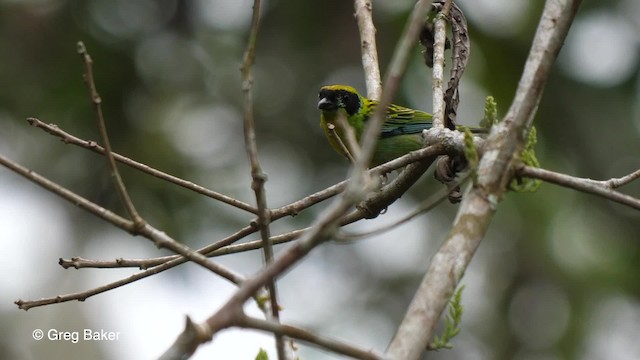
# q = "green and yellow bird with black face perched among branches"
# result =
<box><xmin>318</xmin><ymin>85</ymin><xmax>432</xmax><ymax>167</ymax></box>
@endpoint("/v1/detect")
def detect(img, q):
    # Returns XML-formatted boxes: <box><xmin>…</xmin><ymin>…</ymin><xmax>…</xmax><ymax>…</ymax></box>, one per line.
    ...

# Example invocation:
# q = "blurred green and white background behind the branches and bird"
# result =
<box><xmin>0</xmin><ymin>0</ymin><xmax>640</xmax><ymax>360</ymax></box>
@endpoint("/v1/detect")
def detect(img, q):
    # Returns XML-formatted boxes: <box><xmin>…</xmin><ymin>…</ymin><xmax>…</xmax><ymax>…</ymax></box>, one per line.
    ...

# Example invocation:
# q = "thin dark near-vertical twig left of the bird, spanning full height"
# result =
<box><xmin>241</xmin><ymin>0</ymin><xmax>293</xmax><ymax>360</ymax></box>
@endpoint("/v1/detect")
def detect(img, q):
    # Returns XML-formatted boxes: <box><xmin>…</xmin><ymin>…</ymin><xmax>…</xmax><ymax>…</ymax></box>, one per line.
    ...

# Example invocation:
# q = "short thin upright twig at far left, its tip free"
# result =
<box><xmin>77</xmin><ymin>41</ymin><xmax>145</xmax><ymax>230</ymax></box>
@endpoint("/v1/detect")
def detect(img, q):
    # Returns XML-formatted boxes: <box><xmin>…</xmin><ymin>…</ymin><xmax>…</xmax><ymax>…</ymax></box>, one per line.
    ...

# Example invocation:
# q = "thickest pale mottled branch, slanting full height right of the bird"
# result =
<box><xmin>386</xmin><ymin>0</ymin><xmax>580</xmax><ymax>360</ymax></box>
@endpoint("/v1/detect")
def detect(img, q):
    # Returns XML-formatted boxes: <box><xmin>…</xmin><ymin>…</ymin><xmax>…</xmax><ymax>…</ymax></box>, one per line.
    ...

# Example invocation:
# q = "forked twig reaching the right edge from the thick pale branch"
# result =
<box><xmin>518</xmin><ymin>166</ymin><xmax>640</xmax><ymax>210</ymax></box>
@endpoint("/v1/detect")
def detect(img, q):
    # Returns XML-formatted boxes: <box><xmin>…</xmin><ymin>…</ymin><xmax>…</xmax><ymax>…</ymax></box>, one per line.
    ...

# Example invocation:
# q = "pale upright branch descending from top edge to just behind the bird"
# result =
<box><xmin>353</xmin><ymin>0</ymin><xmax>382</xmax><ymax>100</ymax></box>
